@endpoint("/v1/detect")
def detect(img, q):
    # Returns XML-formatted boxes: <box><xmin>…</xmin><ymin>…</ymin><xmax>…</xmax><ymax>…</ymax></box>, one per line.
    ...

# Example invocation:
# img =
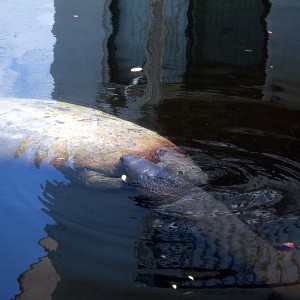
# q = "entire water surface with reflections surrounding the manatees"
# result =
<box><xmin>0</xmin><ymin>0</ymin><xmax>300</xmax><ymax>299</ymax></box>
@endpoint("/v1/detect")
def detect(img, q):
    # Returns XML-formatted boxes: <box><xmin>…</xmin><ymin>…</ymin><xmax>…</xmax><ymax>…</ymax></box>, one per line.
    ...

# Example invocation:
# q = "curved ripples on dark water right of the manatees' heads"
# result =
<box><xmin>186</xmin><ymin>140</ymin><xmax>300</xmax><ymax>223</ymax></box>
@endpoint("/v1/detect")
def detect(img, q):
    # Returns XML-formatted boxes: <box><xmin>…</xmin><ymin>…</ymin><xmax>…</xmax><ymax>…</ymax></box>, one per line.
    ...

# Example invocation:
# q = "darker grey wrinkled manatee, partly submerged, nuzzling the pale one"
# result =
<box><xmin>120</xmin><ymin>154</ymin><xmax>300</xmax><ymax>285</ymax></box>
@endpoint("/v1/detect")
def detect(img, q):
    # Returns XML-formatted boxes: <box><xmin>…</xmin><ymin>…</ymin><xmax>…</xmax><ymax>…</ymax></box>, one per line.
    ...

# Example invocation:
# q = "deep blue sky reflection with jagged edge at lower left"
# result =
<box><xmin>0</xmin><ymin>158</ymin><xmax>66</xmax><ymax>299</ymax></box>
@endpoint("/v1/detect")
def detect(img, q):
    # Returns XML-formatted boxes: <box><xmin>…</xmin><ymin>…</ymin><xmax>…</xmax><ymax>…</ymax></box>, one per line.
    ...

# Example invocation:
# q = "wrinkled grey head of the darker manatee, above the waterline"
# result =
<box><xmin>120</xmin><ymin>154</ymin><xmax>231</xmax><ymax>219</ymax></box>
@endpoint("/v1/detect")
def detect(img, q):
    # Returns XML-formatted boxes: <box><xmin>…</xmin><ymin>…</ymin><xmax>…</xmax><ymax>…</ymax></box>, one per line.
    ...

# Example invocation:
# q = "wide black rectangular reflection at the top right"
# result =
<box><xmin>184</xmin><ymin>0</ymin><xmax>270</xmax><ymax>99</ymax></box>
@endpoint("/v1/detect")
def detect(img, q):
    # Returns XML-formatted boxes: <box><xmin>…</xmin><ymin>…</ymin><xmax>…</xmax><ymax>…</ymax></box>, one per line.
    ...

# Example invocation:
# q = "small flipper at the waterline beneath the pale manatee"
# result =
<box><xmin>79</xmin><ymin>170</ymin><xmax>124</xmax><ymax>190</ymax></box>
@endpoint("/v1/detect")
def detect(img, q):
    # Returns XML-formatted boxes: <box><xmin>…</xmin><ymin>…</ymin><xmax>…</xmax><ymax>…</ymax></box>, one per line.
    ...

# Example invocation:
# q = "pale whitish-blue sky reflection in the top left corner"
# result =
<box><xmin>0</xmin><ymin>0</ymin><xmax>55</xmax><ymax>99</ymax></box>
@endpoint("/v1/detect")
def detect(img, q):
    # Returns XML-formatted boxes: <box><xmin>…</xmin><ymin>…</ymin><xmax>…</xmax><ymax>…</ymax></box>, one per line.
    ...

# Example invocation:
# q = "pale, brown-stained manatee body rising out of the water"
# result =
<box><xmin>0</xmin><ymin>99</ymin><xmax>206</xmax><ymax>182</ymax></box>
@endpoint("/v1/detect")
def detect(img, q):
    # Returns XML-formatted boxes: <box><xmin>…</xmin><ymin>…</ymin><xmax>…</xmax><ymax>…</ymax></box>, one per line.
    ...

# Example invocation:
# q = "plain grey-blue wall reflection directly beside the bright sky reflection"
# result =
<box><xmin>51</xmin><ymin>0</ymin><xmax>109</xmax><ymax>104</ymax></box>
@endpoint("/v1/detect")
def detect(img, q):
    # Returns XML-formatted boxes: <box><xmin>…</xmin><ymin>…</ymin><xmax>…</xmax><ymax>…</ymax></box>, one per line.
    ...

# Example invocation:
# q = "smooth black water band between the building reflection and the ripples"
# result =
<box><xmin>156</xmin><ymin>98</ymin><xmax>300</xmax><ymax>161</ymax></box>
